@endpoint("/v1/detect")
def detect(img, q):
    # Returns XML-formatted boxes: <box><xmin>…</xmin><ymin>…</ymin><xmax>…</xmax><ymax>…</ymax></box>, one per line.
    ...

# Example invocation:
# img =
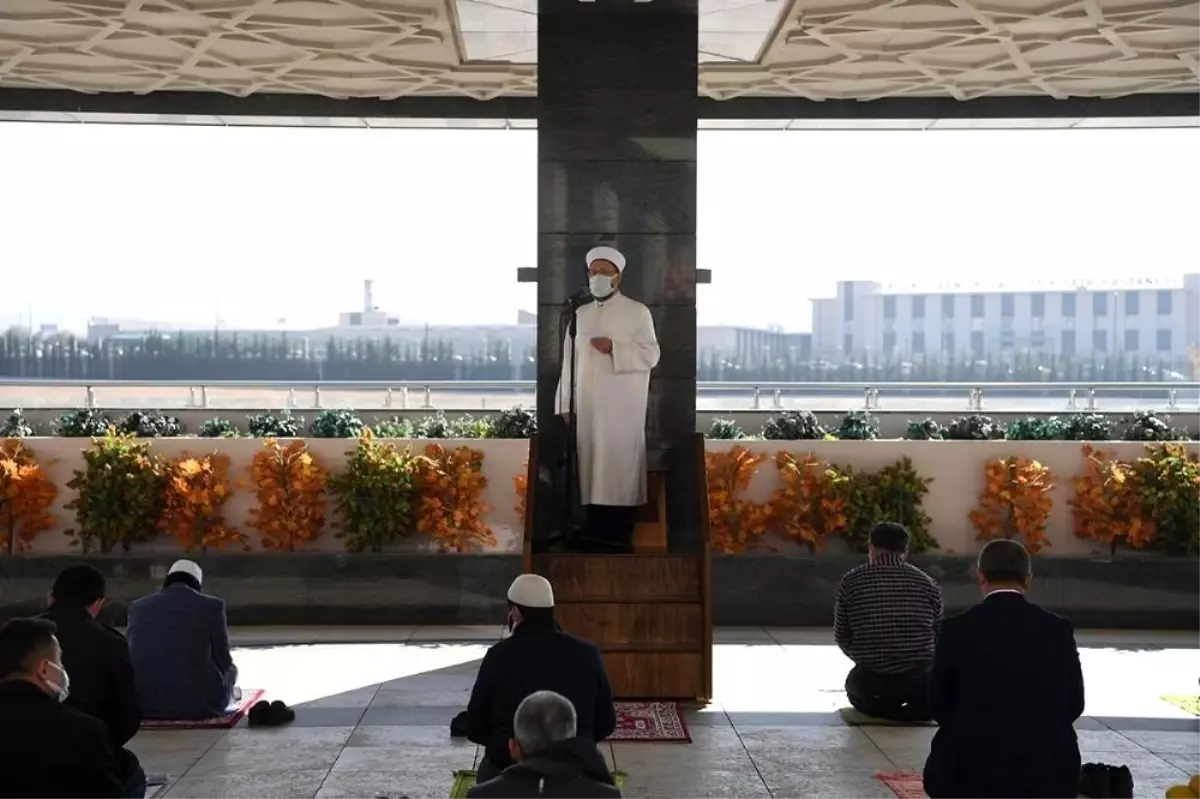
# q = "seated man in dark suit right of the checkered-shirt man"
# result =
<box><xmin>925</xmin><ymin>540</ymin><xmax>1084</xmax><ymax>799</ymax></box>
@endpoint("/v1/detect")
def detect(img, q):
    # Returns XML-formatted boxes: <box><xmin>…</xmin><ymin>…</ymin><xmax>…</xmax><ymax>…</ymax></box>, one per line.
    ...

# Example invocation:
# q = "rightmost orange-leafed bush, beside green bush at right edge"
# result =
<box><xmin>1069</xmin><ymin>444</ymin><xmax>1156</xmax><ymax>553</ymax></box>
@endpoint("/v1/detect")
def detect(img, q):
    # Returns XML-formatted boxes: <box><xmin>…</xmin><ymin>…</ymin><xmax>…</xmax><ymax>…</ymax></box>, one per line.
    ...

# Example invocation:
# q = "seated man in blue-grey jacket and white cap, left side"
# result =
<box><xmin>128</xmin><ymin>560</ymin><xmax>238</xmax><ymax>720</ymax></box>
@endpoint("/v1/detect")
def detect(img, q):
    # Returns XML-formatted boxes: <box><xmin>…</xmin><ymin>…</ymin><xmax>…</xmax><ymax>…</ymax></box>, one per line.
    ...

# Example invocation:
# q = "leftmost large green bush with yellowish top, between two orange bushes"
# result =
<box><xmin>66</xmin><ymin>432</ymin><xmax>166</xmax><ymax>553</ymax></box>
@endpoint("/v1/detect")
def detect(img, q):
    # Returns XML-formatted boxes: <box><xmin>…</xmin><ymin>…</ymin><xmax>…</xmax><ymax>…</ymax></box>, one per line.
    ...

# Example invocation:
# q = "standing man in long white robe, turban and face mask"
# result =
<box><xmin>554</xmin><ymin>246</ymin><xmax>659</xmax><ymax>552</ymax></box>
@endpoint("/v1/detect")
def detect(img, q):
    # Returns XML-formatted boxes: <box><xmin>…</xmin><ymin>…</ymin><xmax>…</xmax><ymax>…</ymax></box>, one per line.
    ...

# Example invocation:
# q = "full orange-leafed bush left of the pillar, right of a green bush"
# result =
<box><xmin>416</xmin><ymin>444</ymin><xmax>496</xmax><ymax>552</ymax></box>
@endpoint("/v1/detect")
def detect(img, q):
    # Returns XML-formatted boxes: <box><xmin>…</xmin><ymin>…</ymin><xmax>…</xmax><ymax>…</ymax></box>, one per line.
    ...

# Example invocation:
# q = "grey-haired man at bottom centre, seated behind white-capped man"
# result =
<box><xmin>467</xmin><ymin>691</ymin><xmax>620</xmax><ymax>799</ymax></box>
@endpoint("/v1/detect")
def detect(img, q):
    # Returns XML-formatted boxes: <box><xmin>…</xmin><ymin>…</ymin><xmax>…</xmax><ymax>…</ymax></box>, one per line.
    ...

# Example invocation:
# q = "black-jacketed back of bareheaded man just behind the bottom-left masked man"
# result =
<box><xmin>42</xmin><ymin>603</ymin><xmax>142</xmax><ymax>746</ymax></box>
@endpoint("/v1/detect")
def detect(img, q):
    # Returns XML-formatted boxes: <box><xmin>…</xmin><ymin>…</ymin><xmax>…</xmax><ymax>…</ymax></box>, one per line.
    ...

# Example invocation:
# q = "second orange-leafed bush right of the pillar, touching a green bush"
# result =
<box><xmin>767</xmin><ymin>452</ymin><xmax>850</xmax><ymax>549</ymax></box>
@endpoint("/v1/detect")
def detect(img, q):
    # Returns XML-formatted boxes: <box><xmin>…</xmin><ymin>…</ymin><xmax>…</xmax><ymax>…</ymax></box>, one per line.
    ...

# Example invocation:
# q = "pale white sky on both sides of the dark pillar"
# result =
<box><xmin>0</xmin><ymin>122</ymin><xmax>1200</xmax><ymax>330</ymax></box>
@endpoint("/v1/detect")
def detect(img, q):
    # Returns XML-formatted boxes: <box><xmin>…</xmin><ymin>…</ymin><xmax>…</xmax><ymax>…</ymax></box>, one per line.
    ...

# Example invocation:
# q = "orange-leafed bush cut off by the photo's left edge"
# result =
<box><xmin>0</xmin><ymin>438</ymin><xmax>59</xmax><ymax>554</ymax></box>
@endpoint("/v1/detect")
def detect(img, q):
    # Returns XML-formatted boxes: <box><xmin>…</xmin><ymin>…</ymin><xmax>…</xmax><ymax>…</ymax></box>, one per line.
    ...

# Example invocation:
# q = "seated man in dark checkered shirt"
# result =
<box><xmin>834</xmin><ymin>522</ymin><xmax>942</xmax><ymax>721</ymax></box>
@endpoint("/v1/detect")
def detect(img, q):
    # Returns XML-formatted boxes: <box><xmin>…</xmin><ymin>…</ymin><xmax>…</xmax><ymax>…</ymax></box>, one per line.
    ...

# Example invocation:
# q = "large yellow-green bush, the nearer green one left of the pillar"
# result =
<box><xmin>328</xmin><ymin>431</ymin><xmax>418</xmax><ymax>552</ymax></box>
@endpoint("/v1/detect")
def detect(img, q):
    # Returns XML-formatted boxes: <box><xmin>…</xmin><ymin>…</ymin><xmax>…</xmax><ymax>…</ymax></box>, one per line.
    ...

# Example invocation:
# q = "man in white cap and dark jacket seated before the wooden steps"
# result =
<box><xmin>467</xmin><ymin>575</ymin><xmax>617</xmax><ymax>782</ymax></box>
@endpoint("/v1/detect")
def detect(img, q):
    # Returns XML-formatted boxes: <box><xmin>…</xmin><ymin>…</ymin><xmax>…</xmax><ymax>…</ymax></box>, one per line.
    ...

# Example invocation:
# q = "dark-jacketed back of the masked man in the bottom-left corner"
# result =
<box><xmin>0</xmin><ymin>680</ymin><xmax>121</xmax><ymax>799</ymax></box>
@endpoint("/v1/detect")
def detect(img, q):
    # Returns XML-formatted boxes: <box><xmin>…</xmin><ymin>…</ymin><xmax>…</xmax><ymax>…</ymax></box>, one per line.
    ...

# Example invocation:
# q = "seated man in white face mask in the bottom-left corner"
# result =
<box><xmin>0</xmin><ymin>619</ymin><xmax>125</xmax><ymax>799</ymax></box>
